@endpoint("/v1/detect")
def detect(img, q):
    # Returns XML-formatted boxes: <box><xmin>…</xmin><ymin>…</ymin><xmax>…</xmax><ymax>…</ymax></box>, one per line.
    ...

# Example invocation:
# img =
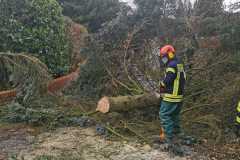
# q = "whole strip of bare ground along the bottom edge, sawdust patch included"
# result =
<box><xmin>0</xmin><ymin>124</ymin><xmax>240</xmax><ymax>160</ymax></box>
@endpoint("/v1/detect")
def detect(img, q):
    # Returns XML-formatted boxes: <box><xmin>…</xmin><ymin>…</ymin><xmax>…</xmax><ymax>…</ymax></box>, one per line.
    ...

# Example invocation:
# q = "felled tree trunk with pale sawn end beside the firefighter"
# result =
<box><xmin>96</xmin><ymin>94</ymin><xmax>160</xmax><ymax>113</ymax></box>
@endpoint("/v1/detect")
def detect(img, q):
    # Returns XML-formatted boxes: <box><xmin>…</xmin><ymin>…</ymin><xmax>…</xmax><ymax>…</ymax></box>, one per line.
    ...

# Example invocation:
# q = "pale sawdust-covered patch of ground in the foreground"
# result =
<box><xmin>18</xmin><ymin>127</ymin><xmax>200</xmax><ymax>160</ymax></box>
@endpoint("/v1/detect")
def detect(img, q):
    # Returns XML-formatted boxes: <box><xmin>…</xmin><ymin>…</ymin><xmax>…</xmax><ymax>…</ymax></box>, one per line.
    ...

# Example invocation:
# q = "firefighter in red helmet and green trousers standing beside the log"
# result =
<box><xmin>159</xmin><ymin>45</ymin><xmax>186</xmax><ymax>143</ymax></box>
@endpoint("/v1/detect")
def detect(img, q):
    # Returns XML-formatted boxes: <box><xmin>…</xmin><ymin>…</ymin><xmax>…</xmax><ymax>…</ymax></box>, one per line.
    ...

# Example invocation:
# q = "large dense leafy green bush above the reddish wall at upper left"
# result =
<box><xmin>0</xmin><ymin>0</ymin><xmax>69</xmax><ymax>73</ymax></box>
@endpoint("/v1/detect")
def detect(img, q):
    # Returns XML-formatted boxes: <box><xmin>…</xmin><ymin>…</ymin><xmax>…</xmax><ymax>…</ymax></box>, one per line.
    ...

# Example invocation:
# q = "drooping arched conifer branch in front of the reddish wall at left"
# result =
<box><xmin>0</xmin><ymin>52</ymin><xmax>50</xmax><ymax>104</ymax></box>
